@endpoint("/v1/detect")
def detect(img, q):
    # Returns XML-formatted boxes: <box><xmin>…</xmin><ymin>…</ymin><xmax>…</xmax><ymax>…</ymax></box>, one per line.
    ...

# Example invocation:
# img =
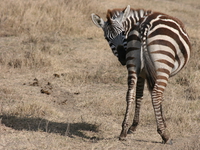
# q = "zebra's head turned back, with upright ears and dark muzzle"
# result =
<box><xmin>91</xmin><ymin>5</ymin><xmax>130</xmax><ymax>65</ymax></box>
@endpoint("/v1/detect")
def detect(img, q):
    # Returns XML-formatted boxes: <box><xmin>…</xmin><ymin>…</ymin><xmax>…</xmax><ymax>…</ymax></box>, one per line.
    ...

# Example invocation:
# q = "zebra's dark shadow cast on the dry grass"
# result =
<box><xmin>0</xmin><ymin>115</ymin><xmax>99</xmax><ymax>140</ymax></box>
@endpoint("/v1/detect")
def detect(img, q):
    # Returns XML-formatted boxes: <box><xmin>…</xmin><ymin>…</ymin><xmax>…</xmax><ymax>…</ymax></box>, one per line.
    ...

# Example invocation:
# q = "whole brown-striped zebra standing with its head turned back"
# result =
<box><xmin>91</xmin><ymin>5</ymin><xmax>191</xmax><ymax>143</ymax></box>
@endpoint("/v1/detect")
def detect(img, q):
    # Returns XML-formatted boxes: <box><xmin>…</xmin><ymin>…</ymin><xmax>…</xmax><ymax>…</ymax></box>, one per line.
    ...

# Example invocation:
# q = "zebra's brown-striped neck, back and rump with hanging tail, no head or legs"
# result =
<box><xmin>124</xmin><ymin>9</ymin><xmax>191</xmax><ymax>91</ymax></box>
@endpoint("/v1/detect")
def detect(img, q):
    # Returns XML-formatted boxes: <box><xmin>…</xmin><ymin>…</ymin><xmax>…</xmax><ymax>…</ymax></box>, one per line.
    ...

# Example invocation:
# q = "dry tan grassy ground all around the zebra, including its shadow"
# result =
<box><xmin>0</xmin><ymin>0</ymin><xmax>200</xmax><ymax>150</ymax></box>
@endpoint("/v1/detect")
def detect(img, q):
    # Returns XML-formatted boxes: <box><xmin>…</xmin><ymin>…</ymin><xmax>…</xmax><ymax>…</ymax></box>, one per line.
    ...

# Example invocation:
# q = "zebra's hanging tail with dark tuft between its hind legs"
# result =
<box><xmin>141</xmin><ymin>28</ymin><xmax>157</xmax><ymax>92</ymax></box>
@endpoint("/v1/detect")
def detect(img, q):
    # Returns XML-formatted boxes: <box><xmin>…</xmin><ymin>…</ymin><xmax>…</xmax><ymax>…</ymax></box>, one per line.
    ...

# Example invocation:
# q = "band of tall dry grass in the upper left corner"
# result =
<box><xmin>0</xmin><ymin>0</ymin><xmax>103</xmax><ymax>37</ymax></box>
